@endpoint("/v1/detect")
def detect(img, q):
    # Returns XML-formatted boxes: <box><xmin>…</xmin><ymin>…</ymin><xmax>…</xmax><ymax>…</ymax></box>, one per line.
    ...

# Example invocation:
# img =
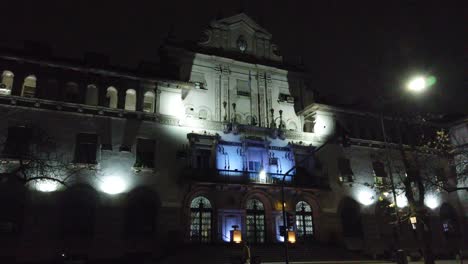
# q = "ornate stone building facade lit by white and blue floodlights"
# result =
<box><xmin>0</xmin><ymin>14</ymin><xmax>467</xmax><ymax>261</ymax></box>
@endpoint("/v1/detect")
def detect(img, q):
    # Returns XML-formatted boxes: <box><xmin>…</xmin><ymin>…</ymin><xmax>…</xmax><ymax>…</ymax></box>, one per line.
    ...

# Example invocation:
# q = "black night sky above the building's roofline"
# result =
<box><xmin>0</xmin><ymin>0</ymin><xmax>468</xmax><ymax>114</ymax></box>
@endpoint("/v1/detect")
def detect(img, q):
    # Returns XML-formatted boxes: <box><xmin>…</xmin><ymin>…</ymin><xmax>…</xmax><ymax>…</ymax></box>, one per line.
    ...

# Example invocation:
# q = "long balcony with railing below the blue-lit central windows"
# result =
<box><xmin>184</xmin><ymin>168</ymin><xmax>329</xmax><ymax>189</ymax></box>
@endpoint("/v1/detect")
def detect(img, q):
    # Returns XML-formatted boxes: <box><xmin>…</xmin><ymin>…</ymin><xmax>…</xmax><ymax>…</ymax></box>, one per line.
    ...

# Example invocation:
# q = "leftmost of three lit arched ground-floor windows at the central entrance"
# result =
<box><xmin>190</xmin><ymin>196</ymin><xmax>212</xmax><ymax>242</ymax></box>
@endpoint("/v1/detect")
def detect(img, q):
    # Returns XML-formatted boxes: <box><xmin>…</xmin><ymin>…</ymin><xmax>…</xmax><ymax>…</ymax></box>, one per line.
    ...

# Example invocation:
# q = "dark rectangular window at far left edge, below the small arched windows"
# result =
<box><xmin>3</xmin><ymin>126</ymin><xmax>32</xmax><ymax>158</ymax></box>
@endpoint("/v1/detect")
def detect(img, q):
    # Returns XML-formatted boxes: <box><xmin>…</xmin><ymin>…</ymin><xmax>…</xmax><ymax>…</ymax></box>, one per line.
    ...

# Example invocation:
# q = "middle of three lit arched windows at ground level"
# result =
<box><xmin>245</xmin><ymin>199</ymin><xmax>266</xmax><ymax>243</ymax></box>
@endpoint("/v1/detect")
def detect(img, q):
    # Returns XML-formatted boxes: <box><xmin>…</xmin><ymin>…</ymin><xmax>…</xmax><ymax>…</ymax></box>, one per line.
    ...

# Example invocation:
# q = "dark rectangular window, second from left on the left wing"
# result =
<box><xmin>75</xmin><ymin>133</ymin><xmax>98</xmax><ymax>164</ymax></box>
